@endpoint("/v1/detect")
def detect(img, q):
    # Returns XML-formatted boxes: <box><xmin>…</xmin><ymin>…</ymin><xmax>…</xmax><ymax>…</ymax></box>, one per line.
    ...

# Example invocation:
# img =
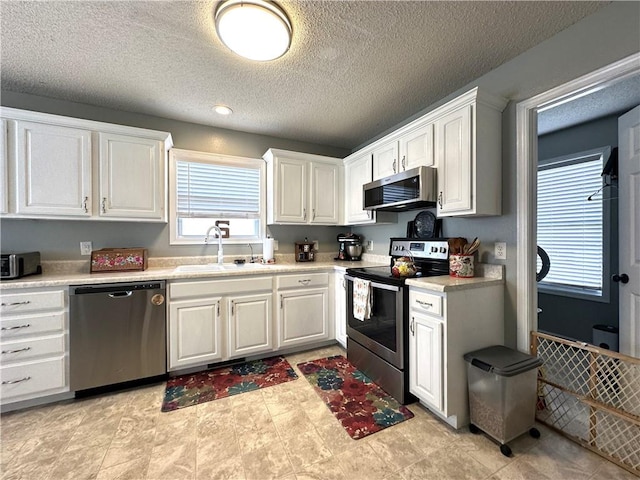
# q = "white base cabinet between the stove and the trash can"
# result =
<box><xmin>409</xmin><ymin>284</ymin><xmax>504</xmax><ymax>428</ymax></box>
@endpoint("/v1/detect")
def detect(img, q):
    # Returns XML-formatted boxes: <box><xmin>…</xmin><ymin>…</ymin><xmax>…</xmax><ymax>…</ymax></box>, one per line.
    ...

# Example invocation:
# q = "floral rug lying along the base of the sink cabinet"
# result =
<box><xmin>162</xmin><ymin>357</ymin><xmax>298</xmax><ymax>412</ymax></box>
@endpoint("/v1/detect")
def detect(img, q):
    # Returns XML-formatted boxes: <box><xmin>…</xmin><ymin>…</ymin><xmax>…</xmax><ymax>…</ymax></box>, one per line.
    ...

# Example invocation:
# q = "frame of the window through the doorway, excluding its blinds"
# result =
<box><xmin>536</xmin><ymin>146</ymin><xmax>612</xmax><ymax>303</ymax></box>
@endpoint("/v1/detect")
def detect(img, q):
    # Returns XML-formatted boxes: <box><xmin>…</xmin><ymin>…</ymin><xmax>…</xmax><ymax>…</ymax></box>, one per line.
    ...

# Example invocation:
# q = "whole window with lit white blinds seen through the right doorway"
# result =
<box><xmin>537</xmin><ymin>147</ymin><xmax>611</xmax><ymax>302</ymax></box>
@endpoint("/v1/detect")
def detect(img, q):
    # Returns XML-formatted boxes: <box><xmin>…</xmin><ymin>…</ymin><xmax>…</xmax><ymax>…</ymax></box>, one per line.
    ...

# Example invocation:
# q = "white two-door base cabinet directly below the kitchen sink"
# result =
<box><xmin>167</xmin><ymin>276</ymin><xmax>273</xmax><ymax>371</ymax></box>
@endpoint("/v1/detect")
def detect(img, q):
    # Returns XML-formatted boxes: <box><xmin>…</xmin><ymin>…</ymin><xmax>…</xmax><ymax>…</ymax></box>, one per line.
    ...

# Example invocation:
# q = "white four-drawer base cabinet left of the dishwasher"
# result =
<box><xmin>0</xmin><ymin>288</ymin><xmax>69</xmax><ymax>406</ymax></box>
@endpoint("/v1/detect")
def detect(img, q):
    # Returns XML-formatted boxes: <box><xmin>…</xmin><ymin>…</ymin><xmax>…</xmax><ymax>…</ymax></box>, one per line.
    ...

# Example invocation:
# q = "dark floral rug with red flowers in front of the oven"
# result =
<box><xmin>298</xmin><ymin>355</ymin><xmax>413</xmax><ymax>440</ymax></box>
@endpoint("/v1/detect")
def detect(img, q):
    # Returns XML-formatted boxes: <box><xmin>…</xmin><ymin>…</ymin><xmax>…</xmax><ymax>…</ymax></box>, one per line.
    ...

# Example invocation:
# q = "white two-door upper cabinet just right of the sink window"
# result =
<box><xmin>264</xmin><ymin>149</ymin><xmax>341</xmax><ymax>225</ymax></box>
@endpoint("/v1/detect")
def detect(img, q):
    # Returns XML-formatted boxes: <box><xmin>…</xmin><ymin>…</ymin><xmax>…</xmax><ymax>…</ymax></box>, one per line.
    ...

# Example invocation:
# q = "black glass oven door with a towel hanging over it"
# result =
<box><xmin>345</xmin><ymin>275</ymin><xmax>406</xmax><ymax>370</ymax></box>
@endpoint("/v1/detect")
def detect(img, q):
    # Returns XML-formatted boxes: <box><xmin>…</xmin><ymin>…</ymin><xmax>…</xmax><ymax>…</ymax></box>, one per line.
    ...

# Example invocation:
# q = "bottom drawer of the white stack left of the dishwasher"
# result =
<box><xmin>0</xmin><ymin>356</ymin><xmax>67</xmax><ymax>402</ymax></box>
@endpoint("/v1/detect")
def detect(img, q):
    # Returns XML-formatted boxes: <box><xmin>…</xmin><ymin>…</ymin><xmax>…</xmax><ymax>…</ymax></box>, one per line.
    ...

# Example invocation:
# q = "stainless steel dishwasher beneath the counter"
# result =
<box><xmin>69</xmin><ymin>281</ymin><xmax>167</xmax><ymax>391</ymax></box>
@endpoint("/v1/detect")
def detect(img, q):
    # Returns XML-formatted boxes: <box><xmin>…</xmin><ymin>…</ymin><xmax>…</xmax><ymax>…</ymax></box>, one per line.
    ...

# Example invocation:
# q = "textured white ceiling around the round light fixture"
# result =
<box><xmin>0</xmin><ymin>0</ymin><xmax>609</xmax><ymax>149</ymax></box>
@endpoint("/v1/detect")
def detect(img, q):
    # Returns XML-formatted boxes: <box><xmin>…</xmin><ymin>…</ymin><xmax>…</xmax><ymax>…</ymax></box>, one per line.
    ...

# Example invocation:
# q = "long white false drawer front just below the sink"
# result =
<box><xmin>169</xmin><ymin>277</ymin><xmax>273</xmax><ymax>300</ymax></box>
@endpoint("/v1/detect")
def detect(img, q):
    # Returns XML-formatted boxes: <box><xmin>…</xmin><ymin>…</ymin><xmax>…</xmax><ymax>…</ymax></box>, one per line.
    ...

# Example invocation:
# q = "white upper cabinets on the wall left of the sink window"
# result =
<box><xmin>0</xmin><ymin>108</ymin><xmax>172</xmax><ymax>222</ymax></box>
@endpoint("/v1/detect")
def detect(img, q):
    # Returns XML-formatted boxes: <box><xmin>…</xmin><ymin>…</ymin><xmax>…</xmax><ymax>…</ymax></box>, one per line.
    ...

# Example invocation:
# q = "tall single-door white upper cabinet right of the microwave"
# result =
<box><xmin>435</xmin><ymin>88</ymin><xmax>506</xmax><ymax>217</ymax></box>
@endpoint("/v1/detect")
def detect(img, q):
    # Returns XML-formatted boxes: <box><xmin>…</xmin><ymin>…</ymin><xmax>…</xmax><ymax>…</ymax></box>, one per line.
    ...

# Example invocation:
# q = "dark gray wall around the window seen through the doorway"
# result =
<box><xmin>538</xmin><ymin>112</ymin><xmax>624</xmax><ymax>342</ymax></box>
